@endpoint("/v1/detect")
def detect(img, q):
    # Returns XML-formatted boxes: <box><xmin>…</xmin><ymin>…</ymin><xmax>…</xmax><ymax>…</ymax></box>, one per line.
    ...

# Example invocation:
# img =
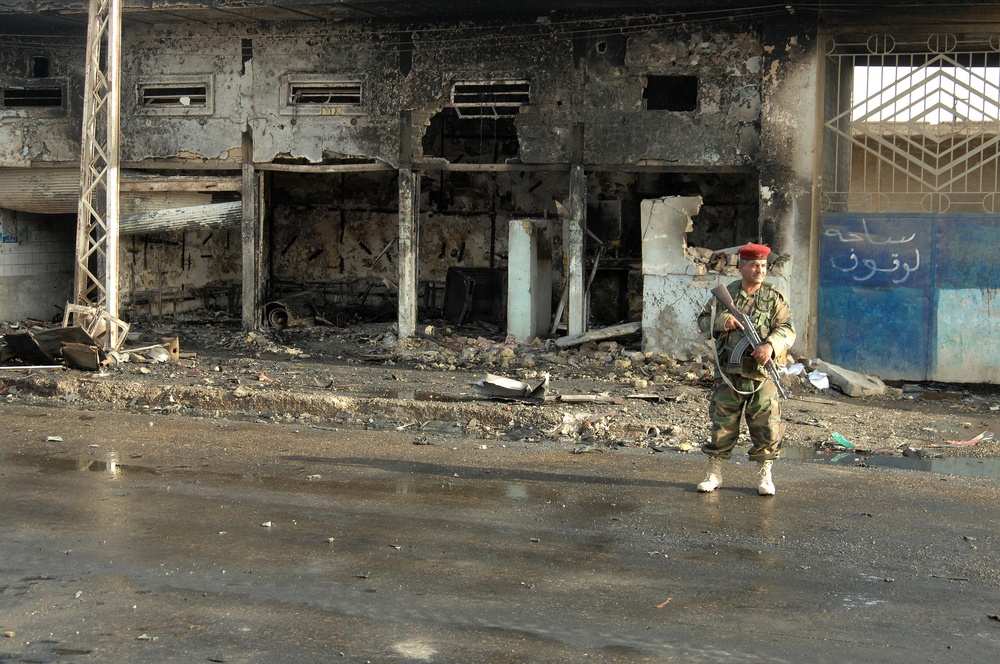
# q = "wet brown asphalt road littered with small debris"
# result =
<box><xmin>0</xmin><ymin>405</ymin><xmax>1000</xmax><ymax>663</ymax></box>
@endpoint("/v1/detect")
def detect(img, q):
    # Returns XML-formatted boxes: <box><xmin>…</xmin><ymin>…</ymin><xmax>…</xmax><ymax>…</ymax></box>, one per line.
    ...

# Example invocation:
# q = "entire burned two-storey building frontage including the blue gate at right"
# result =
<box><xmin>0</xmin><ymin>0</ymin><xmax>1000</xmax><ymax>382</ymax></box>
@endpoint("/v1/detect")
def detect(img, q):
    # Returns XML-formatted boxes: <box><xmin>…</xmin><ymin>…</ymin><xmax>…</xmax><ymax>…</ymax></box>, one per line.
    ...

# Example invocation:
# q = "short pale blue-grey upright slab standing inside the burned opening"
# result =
<box><xmin>507</xmin><ymin>219</ymin><xmax>552</xmax><ymax>342</ymax></box>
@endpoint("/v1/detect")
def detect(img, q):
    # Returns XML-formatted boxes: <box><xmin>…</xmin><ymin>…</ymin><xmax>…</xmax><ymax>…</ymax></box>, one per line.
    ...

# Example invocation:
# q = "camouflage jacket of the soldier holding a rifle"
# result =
<box><xmin>698</xmin><ymin>281</ymin><xmax>795</xmax><ymax>380</ymax></box>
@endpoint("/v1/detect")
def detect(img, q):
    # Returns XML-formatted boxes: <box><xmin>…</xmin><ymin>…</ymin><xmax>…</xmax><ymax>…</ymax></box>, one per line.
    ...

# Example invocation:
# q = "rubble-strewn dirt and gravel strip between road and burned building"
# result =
<box><xmin>0</xmin><ymin>316</ymin><xmax>1000</xmax><ymax>458</ymax></box>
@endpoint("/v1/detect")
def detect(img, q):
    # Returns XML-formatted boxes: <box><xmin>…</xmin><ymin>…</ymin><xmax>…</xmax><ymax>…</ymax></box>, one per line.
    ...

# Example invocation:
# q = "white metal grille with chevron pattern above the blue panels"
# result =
<box><xmin>822</xmin><ymin>34</ymin><xmax>1000</xmax><ymax>213</ymax></box>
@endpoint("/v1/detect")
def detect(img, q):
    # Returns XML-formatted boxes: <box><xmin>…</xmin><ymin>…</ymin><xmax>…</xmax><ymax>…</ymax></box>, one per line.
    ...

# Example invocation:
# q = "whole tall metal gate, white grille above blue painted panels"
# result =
<box><xmin>817</xmin><ymin>34</ymin><xmax>1000</xmax><ymax>382</ymax></box>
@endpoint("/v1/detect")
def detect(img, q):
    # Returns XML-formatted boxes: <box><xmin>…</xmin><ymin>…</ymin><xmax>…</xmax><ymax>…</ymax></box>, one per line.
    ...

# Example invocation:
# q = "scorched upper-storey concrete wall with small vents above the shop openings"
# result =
<box><xmin>122</xmin><ymin>17</ymin><xmax>762</xmax><ymax>168</ymax></box>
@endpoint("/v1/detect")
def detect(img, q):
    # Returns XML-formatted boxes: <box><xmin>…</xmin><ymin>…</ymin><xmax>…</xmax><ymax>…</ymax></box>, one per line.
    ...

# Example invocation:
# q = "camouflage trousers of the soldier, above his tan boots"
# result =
<box><xmin>701</xmin><ymin>375</ymin><xmax>785</xmax><ymax>461</ymax></box>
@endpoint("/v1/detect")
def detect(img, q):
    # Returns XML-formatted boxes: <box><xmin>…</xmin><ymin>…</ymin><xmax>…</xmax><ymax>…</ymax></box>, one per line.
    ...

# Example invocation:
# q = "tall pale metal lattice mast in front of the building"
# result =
<box><xmin>76</xmin><ymin>0</ymin><xmax>121</xmax><ymax>348</ymax></box>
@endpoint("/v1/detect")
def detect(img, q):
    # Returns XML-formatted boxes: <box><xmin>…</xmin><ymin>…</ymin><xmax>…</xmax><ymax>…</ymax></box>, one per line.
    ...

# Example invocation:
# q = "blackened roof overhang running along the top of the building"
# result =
<box><xmin>0</xmin><ymin>0</ymin><xmax>998</xmax><ymax>37</ymax></box>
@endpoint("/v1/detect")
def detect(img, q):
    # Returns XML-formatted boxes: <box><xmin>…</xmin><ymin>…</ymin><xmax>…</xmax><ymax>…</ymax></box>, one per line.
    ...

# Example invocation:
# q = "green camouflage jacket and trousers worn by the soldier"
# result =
<box><xmin>698</xmin><ymin>281</ymin><xmax>795</xmax><ymax>461</ymax></box>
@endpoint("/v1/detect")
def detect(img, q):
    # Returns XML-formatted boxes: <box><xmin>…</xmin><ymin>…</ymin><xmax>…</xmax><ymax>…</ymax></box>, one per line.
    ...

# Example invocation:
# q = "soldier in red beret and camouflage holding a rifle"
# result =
<box><xmin>698</xmin><ymin>244</ymin><xmax>795</xmax><ymax>496</ymax></box>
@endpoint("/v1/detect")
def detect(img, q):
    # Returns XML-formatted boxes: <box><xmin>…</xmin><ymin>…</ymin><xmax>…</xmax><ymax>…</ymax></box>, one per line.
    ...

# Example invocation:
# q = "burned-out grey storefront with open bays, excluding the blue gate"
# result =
<box><xmin>0</xmin><ymin>0</ymin><xmax>992</xmax><ymax>384</ymax></box>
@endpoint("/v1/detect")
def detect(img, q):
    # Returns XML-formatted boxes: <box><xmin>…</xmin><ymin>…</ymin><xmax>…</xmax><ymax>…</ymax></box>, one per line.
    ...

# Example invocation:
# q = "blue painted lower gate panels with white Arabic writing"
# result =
<box><xmin>817</xmin><ymin>214</ymin><xmax>1000</xmax><ymax>383</ymax></box>
